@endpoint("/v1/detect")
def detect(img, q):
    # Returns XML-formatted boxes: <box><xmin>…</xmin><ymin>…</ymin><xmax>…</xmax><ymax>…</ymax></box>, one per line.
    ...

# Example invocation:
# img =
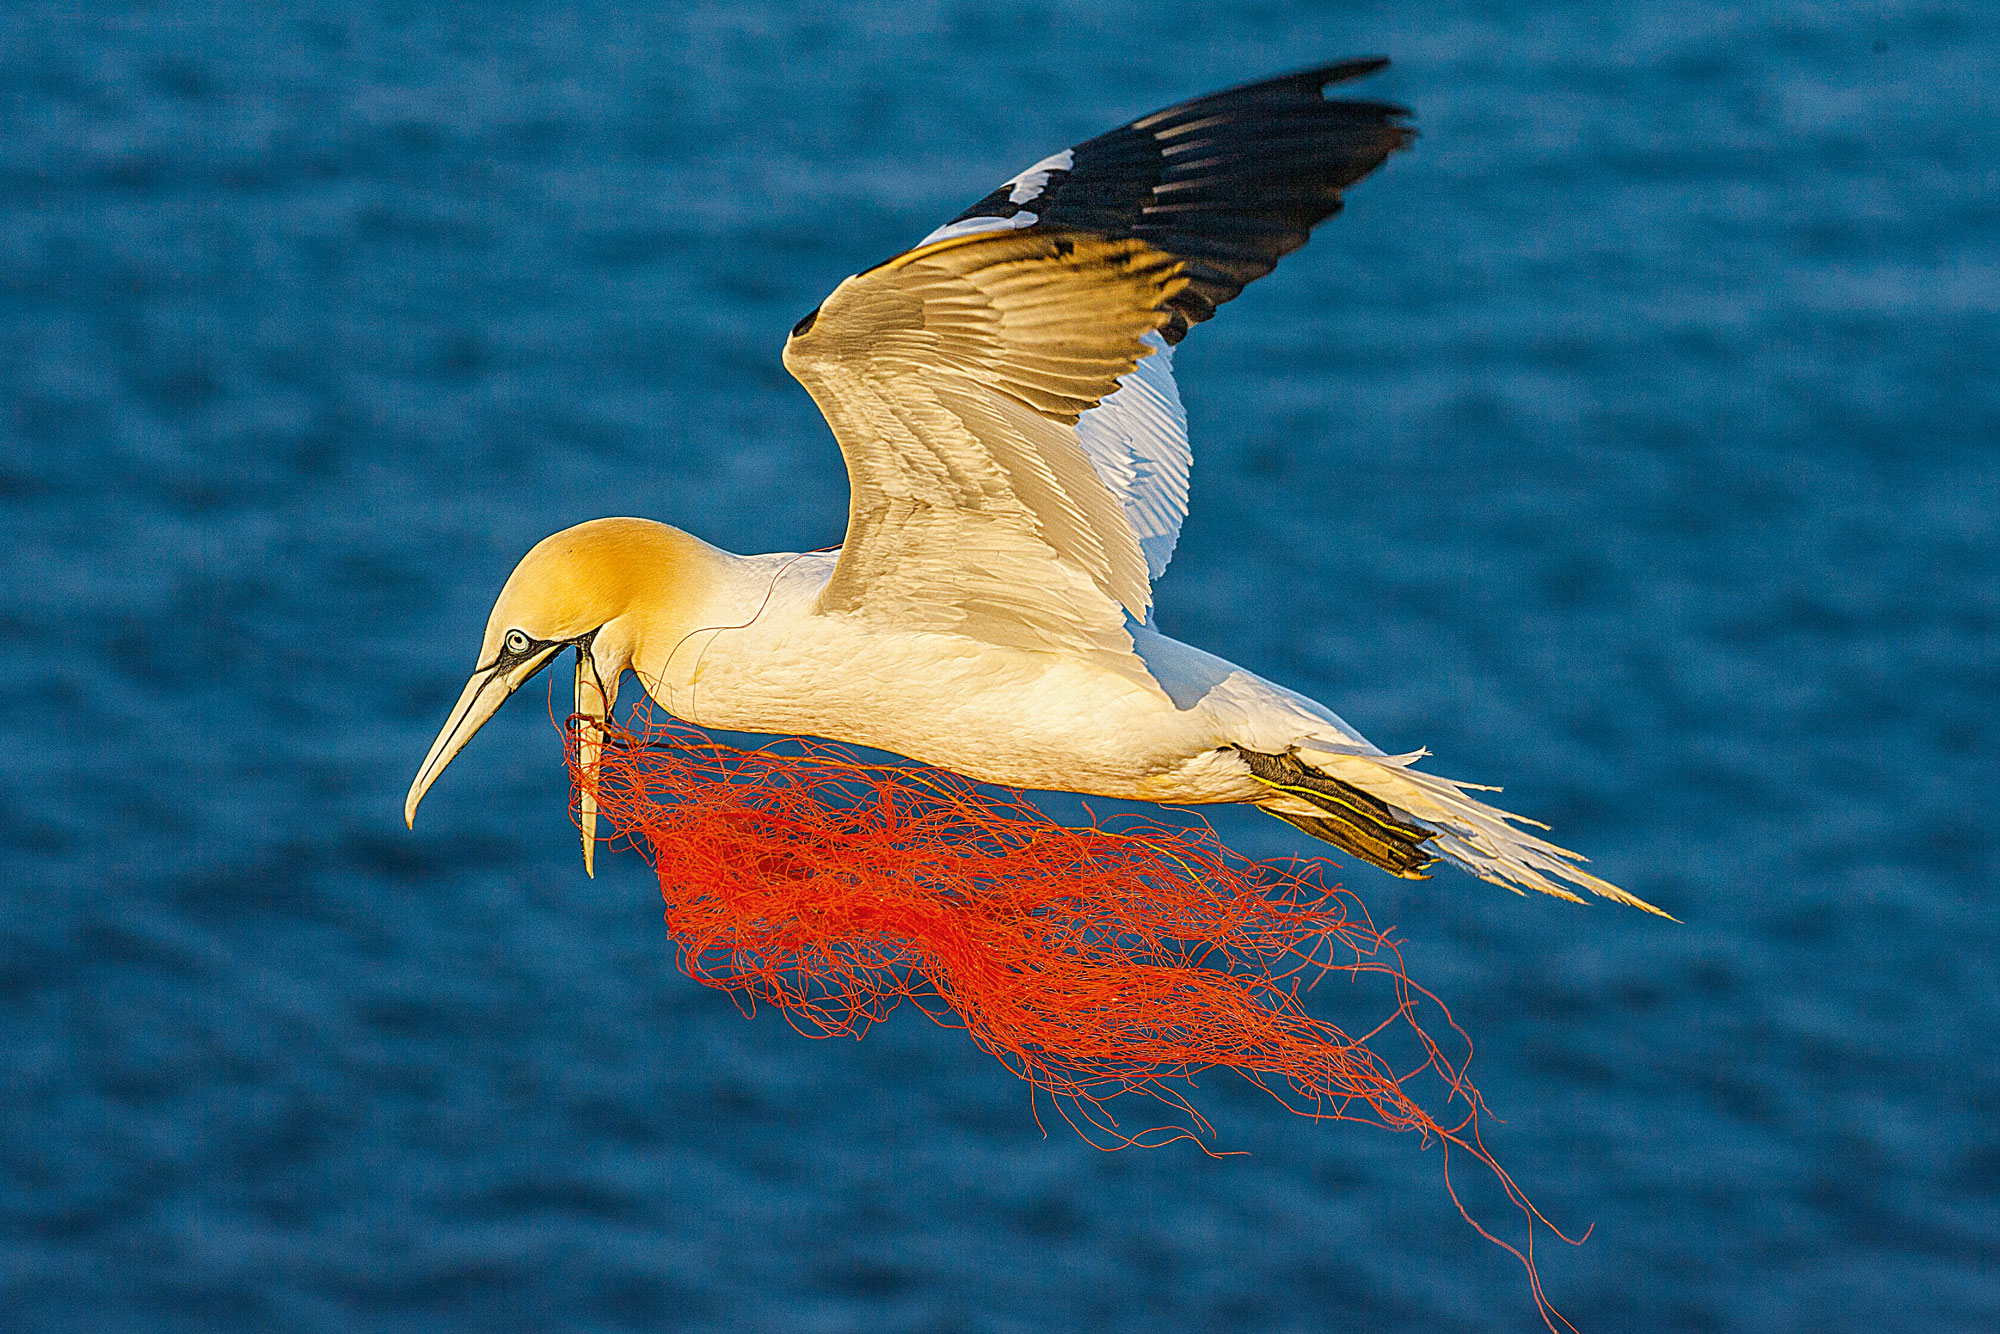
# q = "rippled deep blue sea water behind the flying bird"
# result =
<box><xmin>0</xmin><ymin>0</ymin><xmax>2000</xmax><ymax>1334</ymax></box>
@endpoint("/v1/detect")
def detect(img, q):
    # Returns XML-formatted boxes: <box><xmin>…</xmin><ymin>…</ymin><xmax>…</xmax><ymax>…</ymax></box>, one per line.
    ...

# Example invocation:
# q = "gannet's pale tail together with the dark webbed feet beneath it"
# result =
<box><xmin>1240</xmin><ymin>742</ymin><xmax>1668</xmax><ymax>916</ymax></box>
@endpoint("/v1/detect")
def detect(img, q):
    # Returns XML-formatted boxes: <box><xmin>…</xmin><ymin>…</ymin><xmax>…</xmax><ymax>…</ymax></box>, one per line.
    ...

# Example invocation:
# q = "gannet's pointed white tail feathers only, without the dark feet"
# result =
<box><xmin>1298</xmin><ymin>742</ymin><xmax>1670</xmax><ymax>918</ymax></box>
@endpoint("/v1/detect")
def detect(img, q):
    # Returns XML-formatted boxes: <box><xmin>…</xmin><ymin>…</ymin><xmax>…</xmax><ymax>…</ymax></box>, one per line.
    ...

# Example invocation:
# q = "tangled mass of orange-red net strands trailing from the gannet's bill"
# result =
<box><xmin>568</xmin><ymin>710</ymin><xmax>1568</xmax><ymax>1330</ymax></box>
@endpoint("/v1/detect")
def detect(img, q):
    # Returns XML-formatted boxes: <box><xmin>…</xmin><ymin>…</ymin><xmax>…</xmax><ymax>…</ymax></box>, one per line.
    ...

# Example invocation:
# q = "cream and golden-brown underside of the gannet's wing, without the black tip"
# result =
<box><xmin>784</xmin><ymin>230</ymin><xmax>1186</xmax><ymax>684</ymax></box>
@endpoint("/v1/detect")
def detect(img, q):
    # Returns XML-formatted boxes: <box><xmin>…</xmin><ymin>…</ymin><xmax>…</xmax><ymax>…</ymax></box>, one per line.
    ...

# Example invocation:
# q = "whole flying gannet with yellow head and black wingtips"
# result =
<box><xmin>404</xmin><ymin>58</ymin><xmax>1658</xmax><ymax>912</ymax></box>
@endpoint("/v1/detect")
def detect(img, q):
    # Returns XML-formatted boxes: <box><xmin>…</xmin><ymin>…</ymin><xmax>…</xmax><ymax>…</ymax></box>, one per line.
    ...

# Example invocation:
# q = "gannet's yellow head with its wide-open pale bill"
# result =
<box><xmin>402</xmin><ymin>518</ymin><xmax>708</xmax><ymax>868</ymax></box>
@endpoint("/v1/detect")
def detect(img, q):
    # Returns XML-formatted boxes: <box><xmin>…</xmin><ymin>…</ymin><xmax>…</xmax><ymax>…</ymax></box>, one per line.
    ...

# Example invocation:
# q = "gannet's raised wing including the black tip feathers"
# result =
<box><xmin>784</xmin><ymin>60</ymin><xmax>1414</xmax><ymax>674</ymax></box>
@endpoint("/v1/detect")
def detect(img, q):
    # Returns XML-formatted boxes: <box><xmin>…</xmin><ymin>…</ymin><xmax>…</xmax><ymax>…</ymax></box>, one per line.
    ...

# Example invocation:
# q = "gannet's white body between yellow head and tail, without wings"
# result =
<box><xmin>634</xmin><ymin>552</ymin><xmax>1374</xmax><ymax>804</ymax></box>
